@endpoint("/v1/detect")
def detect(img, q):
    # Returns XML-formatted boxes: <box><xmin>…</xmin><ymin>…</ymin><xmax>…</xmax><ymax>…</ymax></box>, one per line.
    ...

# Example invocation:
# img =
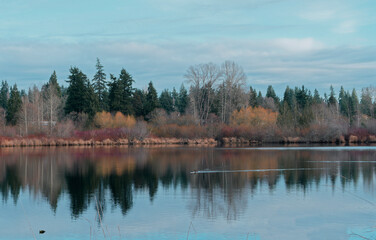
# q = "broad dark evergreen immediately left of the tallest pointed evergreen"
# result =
<box><xmin>64</xmin><ymin>67</ymin><xmax>98</xmax><ymax>118</ymax></box>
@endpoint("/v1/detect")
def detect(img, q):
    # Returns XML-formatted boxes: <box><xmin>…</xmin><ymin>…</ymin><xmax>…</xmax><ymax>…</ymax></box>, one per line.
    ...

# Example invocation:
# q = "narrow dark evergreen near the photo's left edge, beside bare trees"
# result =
<box><xmin>6</xmin><ymin>84</ymin><xmax>22</xmax><ymax>126</ymax></box>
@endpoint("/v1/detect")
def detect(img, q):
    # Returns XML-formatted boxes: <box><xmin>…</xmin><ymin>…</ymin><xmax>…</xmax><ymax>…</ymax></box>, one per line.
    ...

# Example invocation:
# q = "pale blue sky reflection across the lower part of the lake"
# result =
<box><xmin>0</xmin><ymin>173</ymin><xmax>376</xmax><ymax>240</ymax></box>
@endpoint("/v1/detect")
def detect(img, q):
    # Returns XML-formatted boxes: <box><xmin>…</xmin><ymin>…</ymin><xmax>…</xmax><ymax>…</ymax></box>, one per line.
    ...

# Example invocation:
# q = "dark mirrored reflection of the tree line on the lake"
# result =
<box><xmin>0</xmin><ymin>148</ymin><xmax>376</xmax><ymax>220</ymax></box>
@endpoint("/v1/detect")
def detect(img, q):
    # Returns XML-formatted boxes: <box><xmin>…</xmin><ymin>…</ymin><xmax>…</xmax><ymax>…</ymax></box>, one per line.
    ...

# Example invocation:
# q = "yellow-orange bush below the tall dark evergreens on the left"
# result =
<box><xmin>94</xmin><ymin>111</ymin><xmax>136</xmax><ymax>128</ymax></box>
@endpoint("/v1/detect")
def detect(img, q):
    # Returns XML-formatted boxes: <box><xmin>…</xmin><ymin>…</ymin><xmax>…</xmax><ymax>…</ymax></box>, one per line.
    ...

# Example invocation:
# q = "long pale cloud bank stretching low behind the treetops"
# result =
<box><xmin>0</xmin><ymin>38</ymin><xmax>376</xmax><ymax>93</ymax></box>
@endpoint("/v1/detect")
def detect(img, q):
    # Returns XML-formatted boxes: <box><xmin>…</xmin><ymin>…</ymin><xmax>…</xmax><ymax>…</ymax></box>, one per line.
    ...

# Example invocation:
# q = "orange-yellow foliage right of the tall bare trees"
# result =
<box><xmin>231</xmin><ymin>107</ymin><xmax>278</xmax><ymax>127</ymax></box>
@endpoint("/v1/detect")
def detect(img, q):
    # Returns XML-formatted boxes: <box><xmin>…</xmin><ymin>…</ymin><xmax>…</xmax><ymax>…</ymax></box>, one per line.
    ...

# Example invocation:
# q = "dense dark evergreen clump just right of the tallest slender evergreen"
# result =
<box><xmin>109</xmin><ymin>68</ymin><xmax>134</xmax><ymax>115</ymax></box>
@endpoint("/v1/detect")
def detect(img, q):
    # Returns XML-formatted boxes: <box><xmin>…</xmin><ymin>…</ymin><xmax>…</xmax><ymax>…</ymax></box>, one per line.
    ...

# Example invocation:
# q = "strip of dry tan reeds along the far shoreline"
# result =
<box><xmin>0</xmin><ymin>135</ymin><xmax>376</xmax><ymax>148</ymax></box>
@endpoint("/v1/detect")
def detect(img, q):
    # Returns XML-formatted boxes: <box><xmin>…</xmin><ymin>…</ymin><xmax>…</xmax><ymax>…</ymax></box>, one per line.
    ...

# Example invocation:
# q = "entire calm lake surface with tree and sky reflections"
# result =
<box><xmin>0</xmin><ymin>147</ymin><xmax>376</xmax><ymax>240</ymax></box>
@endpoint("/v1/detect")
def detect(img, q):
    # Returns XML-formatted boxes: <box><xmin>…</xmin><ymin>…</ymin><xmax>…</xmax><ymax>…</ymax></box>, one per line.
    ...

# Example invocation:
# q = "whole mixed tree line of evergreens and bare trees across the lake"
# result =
<box><xmin>0</xmin><ymin>59</ymin><xmax>376</xmax><ymax>140</ymax></box>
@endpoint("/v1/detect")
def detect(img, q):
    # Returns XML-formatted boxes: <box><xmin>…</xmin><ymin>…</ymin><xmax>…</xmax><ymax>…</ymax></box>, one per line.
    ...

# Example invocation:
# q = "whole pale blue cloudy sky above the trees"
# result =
<box><xmin>0</xmin><ymin>0</ymin><xmax>376</xmax><ymax>95</ymax></box>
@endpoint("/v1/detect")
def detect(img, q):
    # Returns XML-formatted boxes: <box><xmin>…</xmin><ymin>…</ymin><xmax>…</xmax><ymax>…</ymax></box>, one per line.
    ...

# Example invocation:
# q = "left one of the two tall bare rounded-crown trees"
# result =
<box><xmin>184</xmin><ymin>63</ymin><xmax>222</xmax><ymax>125</ymax></box>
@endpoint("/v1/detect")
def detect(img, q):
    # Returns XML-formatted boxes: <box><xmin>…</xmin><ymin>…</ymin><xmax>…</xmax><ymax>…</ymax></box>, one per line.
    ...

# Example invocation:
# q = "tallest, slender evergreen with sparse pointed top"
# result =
<box><xmin>93</xmin><ymin>58</ymin><xmax>108</xmax><ymax>111</ymax></box>
